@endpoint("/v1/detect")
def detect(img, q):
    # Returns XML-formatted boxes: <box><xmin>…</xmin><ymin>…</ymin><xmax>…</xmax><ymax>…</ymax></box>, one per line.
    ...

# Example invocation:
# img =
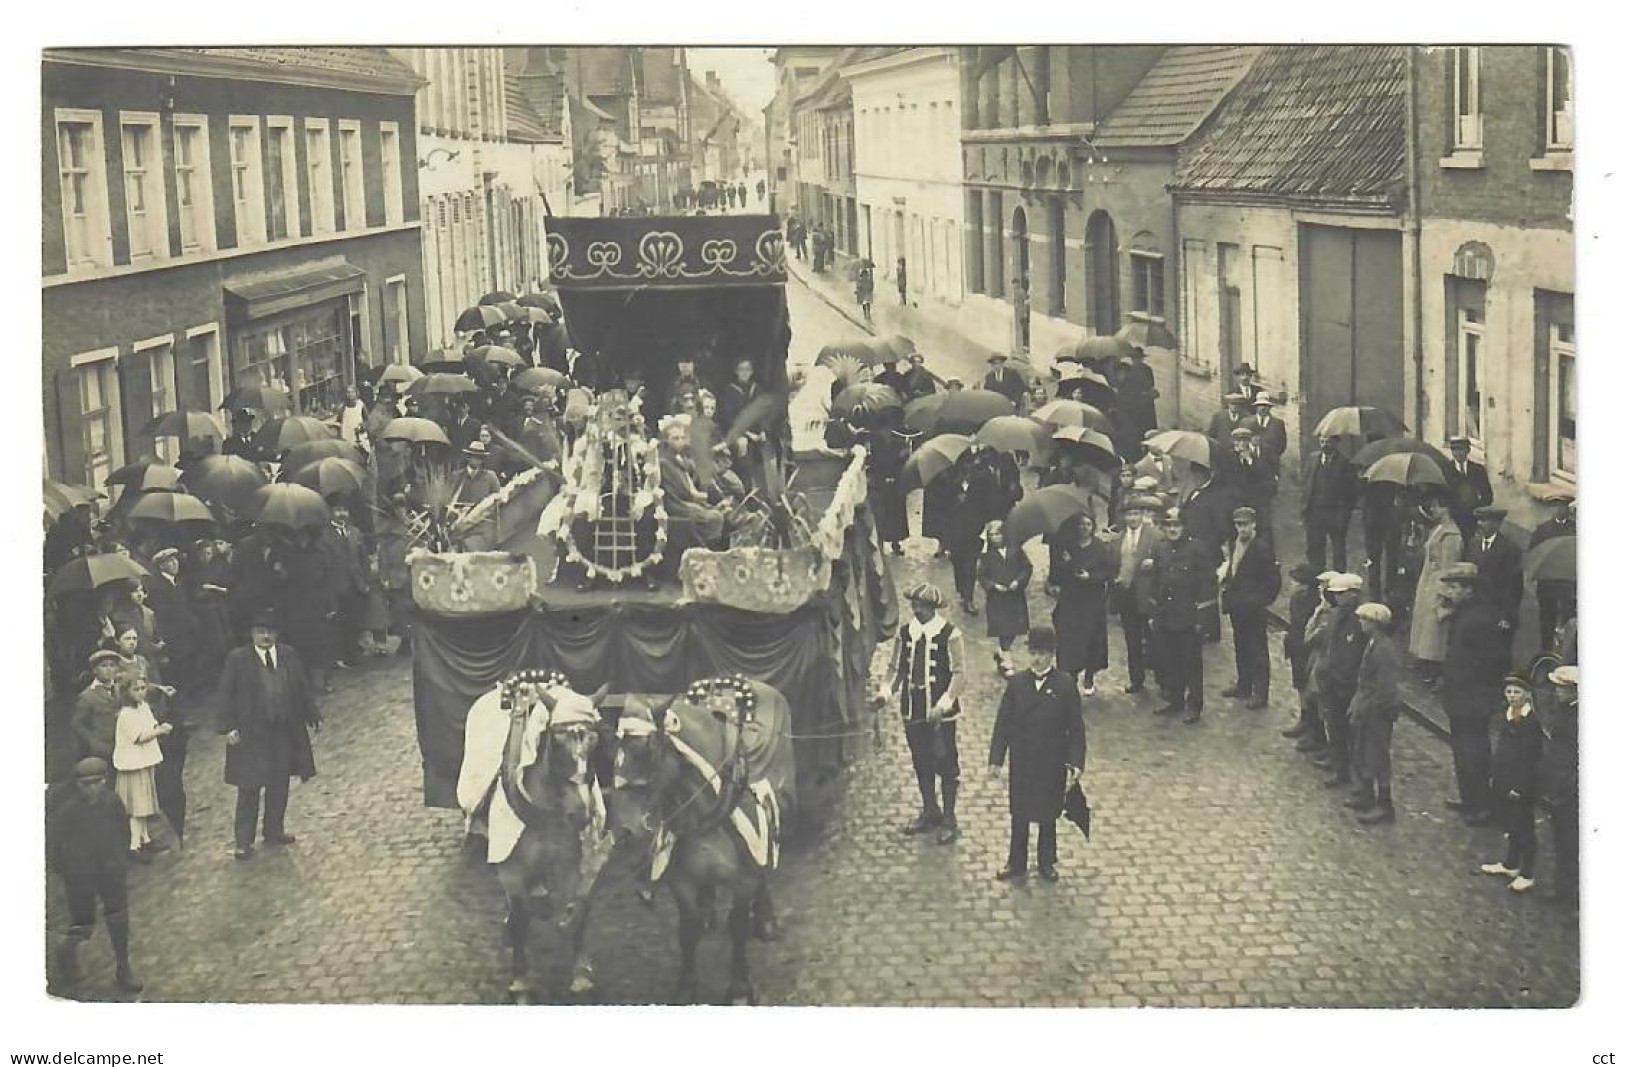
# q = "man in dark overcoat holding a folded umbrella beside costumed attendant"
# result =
<box><xmin>988</xmin><ymin>625</ymin><xmax>1087</xmax><ymax>882</ymax></box>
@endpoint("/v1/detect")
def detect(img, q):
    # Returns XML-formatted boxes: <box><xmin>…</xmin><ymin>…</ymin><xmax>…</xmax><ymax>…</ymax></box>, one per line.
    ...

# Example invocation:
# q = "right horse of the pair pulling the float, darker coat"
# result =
<box><xmin>611</xmin><ymin>677</ymin><xmax>795</xmax><ymax>1004</ymax></box>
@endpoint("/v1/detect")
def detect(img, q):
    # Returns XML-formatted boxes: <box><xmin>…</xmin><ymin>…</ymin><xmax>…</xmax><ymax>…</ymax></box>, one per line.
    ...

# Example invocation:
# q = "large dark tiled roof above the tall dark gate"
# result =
<box><xmin>1173</xmin><ymin>45</ymin><xmax>1406</xmax><ymax>210</ymax></box>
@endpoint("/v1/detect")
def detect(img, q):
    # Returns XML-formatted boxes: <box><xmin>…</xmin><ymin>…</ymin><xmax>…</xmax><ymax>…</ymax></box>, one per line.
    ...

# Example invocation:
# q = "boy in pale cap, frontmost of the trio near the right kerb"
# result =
<box><xmin>1347</xmin><ymin>604</ymin><xmax>1399</xmax><ymax>827</ymax></box>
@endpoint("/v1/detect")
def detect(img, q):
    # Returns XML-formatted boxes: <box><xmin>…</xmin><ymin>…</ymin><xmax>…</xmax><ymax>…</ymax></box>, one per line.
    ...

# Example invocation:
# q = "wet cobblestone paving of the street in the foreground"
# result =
<box><xmin>49</xmin><ymin>283</ymin><xmax>1580</xmax><ymax>1007</ymax></box>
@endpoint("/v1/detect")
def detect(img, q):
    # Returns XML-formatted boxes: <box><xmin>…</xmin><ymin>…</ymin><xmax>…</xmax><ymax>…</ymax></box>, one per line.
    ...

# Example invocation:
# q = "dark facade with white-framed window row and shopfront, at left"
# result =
<box><xmin>41</xmin><ymin>47</ymin><xmax>426</xmax><ymax>486</ymax></box>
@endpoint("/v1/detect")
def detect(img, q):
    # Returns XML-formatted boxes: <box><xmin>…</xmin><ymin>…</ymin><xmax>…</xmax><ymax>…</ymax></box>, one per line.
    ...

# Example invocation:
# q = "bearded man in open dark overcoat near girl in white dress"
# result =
<box><xmin>215</xmin><ymin>611</ymin><xmax>322</xmax><ymax>859</ymax></box>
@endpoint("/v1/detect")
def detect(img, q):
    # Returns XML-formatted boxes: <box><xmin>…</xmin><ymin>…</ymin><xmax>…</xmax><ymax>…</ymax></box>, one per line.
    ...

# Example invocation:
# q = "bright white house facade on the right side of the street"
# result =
<box><xmin>842</xmin><ymin>47</ymin><xmax>965</xmax><ymax>307</ymax></box>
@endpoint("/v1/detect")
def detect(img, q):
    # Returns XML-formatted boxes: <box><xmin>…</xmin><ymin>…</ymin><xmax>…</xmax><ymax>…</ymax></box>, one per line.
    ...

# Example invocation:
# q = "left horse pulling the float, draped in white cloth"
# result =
<box><xmin>465</xmin><ymin>674</ymin><xmax>613</xmax><ymax>1004</ymax></box>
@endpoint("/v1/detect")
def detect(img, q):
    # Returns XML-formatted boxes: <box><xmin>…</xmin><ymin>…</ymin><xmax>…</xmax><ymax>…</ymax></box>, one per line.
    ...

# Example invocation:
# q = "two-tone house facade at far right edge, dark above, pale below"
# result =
<box><xmin>1412</xmin><ymin>45</ymin><xmax>1578</xmax><ymax>529</ymax></box>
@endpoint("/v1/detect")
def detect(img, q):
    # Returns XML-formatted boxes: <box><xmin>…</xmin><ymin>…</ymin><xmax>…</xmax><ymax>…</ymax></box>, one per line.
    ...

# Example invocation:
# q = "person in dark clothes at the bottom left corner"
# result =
<box><xmin>46</xmin><ymin>757</ymin><xmax>141</xmax><ymax>994</ymax></box>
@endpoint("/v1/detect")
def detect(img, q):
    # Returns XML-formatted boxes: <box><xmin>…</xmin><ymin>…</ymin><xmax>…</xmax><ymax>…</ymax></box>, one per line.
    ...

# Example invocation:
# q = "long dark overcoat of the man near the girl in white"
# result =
<box><xmin>215</xmin><ymin>645</ymin><xmax>322</xmax><ymax>789</ymax></box>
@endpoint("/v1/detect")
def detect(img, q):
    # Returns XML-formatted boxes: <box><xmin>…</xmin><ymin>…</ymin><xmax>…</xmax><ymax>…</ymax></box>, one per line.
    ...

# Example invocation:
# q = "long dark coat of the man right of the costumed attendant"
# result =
<box><xmin>988</xmin><ymin>669</ymin><xmax>1089</xmax><ymax>822</ymax></box>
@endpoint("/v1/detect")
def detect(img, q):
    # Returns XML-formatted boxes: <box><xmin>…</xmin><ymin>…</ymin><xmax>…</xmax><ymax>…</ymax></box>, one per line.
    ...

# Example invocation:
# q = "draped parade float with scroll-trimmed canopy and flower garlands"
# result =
<box><xmin>411</xmin><ymin>216</ymin><xmax>897</xmax><ymax>807</ymax></box>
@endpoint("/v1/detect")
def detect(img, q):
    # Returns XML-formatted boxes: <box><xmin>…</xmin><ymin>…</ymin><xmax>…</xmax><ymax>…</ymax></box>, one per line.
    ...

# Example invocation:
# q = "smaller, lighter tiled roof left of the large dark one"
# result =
<box><xmin>1095</xmin><ymin>44</ymin><xmax>1258</xmax><ymax>148</ymax></box>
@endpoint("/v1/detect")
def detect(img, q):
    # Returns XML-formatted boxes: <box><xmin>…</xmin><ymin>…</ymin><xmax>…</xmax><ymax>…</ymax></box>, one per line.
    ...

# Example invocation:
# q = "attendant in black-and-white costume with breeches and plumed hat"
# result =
<box><xmin>891</xmin><ymin>581</ymin><xmax>965</xmax><ymax>845</ymax></box>
